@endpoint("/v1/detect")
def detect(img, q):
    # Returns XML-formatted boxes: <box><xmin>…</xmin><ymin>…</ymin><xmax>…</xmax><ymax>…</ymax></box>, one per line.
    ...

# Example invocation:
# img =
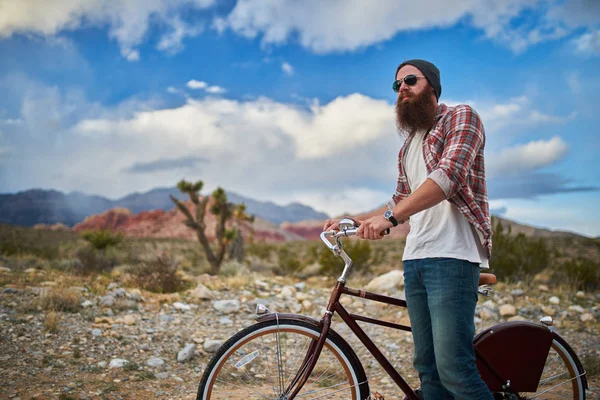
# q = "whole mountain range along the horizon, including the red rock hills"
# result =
<box><xmin>0</xmin><ymin>187</ymin><xmax>581</xmax><ymax>239</ymax></box>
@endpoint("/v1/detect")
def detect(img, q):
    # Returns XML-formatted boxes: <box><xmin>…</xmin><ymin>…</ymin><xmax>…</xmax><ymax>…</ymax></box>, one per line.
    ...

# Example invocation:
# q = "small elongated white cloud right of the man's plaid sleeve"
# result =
<box><xmin>486</xmin><ymin>136</ymin><xmax>568</xmax><ymax>178</ymax></box>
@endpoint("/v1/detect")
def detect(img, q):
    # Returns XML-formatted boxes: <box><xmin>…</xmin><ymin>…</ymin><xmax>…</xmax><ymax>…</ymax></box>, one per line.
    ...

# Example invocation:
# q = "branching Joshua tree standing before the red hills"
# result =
<box><xmin>169</xmin><ymin>180</ymin><xmax>254</xmax><ymax>275</ymax></box>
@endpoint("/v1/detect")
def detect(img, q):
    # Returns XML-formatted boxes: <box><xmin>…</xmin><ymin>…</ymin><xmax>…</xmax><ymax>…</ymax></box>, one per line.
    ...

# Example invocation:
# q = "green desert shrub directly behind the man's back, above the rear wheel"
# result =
<box><xmin>490</xmin><ymin>221</ymin><xmax>551</xmax><ymax>280</ymax></box>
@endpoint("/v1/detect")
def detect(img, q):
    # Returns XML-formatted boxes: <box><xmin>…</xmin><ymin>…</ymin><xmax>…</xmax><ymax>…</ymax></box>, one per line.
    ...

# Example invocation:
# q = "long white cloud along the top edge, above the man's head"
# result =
<box><xmin>218</xmin><ymin>0</ymin><xmax>598</xmax><ymax>53</ymax></box>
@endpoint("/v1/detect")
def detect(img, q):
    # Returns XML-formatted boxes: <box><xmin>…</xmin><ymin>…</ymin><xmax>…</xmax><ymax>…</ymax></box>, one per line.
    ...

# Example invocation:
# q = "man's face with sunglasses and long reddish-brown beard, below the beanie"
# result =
<box><xmin>396</xmin><ymin>65</ymin><xmax>437</xmax><ymax>135</ymax></box>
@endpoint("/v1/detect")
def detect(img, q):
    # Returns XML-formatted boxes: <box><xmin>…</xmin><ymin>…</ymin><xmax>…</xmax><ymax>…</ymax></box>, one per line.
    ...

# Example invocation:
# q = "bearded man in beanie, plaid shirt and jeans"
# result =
<box><xmin>324</xmin><ymin>60</ymin><xmax>493</xmax><ymax>400</ymax></box>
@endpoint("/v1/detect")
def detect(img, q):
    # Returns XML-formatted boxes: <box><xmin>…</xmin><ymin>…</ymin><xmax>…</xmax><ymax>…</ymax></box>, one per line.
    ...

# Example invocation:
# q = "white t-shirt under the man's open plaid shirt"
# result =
<box><xmin>402</xmin><ymin>131</ymin><xmax>489</xmax><ymax>268</ymax></box>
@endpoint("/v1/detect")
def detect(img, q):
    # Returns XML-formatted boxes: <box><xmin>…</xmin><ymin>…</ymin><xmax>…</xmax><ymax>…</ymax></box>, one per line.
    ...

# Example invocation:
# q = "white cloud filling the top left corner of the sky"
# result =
<box><xmin>0</xmin><ymin>0</ymin><xmax>215</xmax><ymax>61</ymax></box>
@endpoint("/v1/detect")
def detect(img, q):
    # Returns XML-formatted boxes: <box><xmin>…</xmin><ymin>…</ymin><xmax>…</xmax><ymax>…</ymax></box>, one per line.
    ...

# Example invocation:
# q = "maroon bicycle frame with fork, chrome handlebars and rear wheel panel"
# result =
<box><xmin>252</xmin><ymin>229</ymin><xmax>587</xmax><ymax>400</ymax></box>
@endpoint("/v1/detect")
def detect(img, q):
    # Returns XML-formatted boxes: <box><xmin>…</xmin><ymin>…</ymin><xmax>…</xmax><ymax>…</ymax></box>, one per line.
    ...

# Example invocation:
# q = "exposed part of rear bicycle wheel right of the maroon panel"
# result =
<box><xmin>519</xmin><ymin>335</ymin><xmax>587</xmax><ymax>400</ymax></box>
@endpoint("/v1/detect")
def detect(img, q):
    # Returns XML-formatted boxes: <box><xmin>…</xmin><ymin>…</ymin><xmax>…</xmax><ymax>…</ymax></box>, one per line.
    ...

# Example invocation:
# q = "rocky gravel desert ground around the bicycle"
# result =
<box><xmin>0</xmin><ymin>271</ymin><xmax>600</xmax><ymax>400</ymax></box>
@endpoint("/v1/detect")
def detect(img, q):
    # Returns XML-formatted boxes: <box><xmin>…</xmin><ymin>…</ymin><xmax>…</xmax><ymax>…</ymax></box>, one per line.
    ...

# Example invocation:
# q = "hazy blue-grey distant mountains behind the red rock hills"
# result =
<box><xmin>0</xmin><ymin>187</ymin><xmax>328</xmax><ymax>226</ymax></box>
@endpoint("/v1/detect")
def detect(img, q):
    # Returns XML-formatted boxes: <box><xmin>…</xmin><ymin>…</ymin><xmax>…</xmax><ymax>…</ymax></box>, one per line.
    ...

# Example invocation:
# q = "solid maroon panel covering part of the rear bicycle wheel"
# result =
<box><xmin>473</xmin><ymin>321</ymin><xmax>555</xmax><ymax>392</ymax></box>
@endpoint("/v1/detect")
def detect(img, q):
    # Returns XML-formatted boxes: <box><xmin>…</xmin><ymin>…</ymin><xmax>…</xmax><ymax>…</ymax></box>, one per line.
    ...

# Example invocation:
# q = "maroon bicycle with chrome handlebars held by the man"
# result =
<box><xmin>196</xmin><ymin>219</ymin><xmax>588</xmax><ymax>400</ymax></box>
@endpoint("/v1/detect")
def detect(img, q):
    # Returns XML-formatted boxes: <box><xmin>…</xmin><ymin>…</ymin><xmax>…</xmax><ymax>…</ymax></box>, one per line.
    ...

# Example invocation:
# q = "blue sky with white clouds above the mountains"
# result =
<box><xmin>0</xmin><ymin>0</ymin><xmax>600</xmax><ymax>237</ymax></box>
